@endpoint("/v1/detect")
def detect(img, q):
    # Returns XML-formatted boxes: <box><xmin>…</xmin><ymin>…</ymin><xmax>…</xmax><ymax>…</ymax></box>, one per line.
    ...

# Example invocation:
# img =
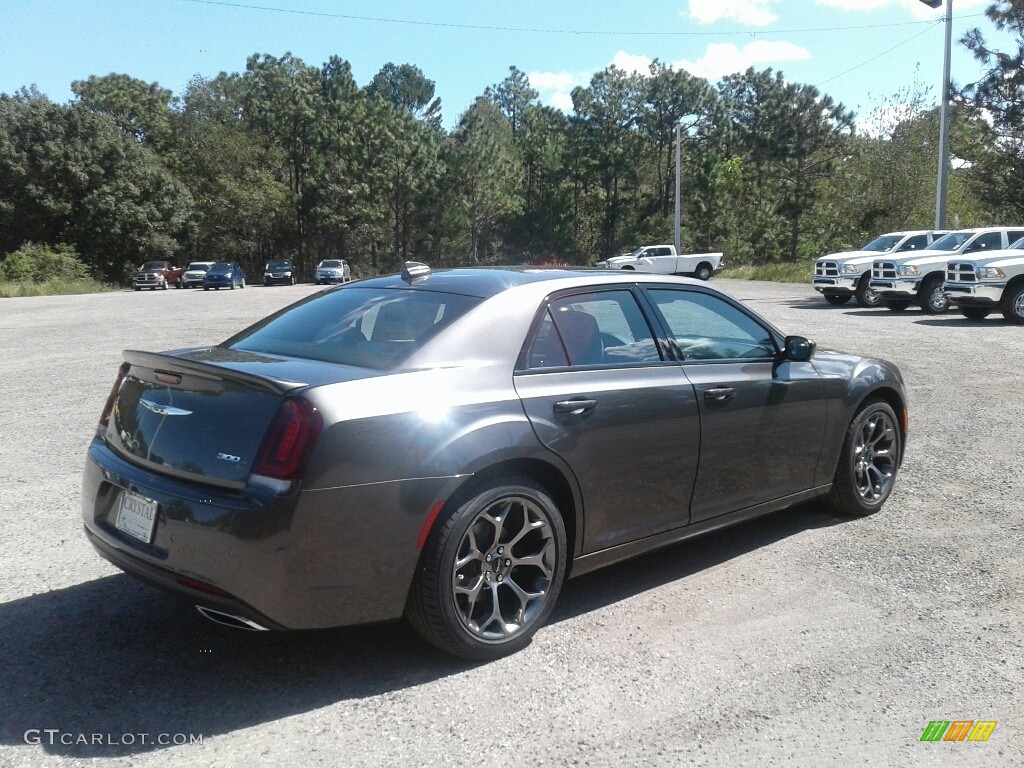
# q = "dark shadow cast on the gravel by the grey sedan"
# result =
<box><xmin>0</xmin><ymin>504</ymin><xmax>842</xmax><ymax>758</ymax></box>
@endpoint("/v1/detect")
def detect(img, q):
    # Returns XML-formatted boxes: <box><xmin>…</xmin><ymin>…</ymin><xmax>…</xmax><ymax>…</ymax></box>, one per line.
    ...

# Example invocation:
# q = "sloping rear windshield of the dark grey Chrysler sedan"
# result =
<box><xmin>227</xmin><ymin>288</ymin><xmax>480</xmax><ymax>370</ymax></box>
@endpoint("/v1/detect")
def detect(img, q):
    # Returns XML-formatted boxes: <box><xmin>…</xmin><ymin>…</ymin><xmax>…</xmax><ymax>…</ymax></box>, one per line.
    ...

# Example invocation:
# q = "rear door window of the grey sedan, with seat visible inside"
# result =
<box><xmin>526</xmin><ymin>291</ymin><xmax>662</xmax><ymax>369</ymax></box>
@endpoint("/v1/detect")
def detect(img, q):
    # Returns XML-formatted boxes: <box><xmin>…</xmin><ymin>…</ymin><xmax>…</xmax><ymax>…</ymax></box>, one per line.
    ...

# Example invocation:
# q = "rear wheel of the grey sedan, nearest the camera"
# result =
<box><xmin>406</xmin><ymin>475</ymin><xmax>567</xmax><ymax>660</ymax></box>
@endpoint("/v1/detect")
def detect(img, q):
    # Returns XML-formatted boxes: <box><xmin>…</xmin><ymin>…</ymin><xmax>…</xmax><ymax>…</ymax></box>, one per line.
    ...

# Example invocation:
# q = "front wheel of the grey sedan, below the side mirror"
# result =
<box><xmin>827</xmin><ymin>398</ymin><xmax>903</xmax><ymax>517</ymax></box>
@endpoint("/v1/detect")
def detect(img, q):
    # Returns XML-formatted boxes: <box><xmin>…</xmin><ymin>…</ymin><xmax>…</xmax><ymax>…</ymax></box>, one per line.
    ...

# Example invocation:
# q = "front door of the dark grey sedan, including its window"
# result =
<box><xmin>645</xmin><ymin>287</ymin><xmax>825</xmax><ymax>522</ymax></box>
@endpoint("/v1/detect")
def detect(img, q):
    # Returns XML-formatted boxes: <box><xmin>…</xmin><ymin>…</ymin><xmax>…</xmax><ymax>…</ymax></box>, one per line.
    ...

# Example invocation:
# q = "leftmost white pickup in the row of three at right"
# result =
<box><xmin>811</xmin><ymin>229</ymin><xmax>946</xmax><ymax>308</ymax></box>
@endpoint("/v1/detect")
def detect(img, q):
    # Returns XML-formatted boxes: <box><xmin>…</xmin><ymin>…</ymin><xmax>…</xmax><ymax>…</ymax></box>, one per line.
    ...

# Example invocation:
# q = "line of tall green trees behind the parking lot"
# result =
<box><xmin>6</xmin><ymin>1</ymin><xmax>1024</xmax><ymax>282</ymax></box>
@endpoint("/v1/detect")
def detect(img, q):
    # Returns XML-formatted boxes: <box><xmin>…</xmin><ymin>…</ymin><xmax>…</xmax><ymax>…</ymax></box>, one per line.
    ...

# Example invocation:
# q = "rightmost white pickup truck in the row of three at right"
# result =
<box><xmin>942</xmin><ymin>239</ymin><xmax>1024</xmax><ymax>326</ymax></box>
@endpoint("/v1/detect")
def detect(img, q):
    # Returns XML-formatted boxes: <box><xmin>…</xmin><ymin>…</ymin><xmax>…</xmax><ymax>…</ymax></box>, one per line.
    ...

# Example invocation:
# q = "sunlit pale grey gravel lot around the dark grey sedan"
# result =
<box><xmin>0</xmin><ymin>280</ymin><xmax>1024</xmax><ymax>767</ymax></box>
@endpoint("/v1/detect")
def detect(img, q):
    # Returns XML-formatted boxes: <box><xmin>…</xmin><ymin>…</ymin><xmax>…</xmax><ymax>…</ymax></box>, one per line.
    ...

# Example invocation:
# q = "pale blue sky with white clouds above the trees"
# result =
<box><xmin>0</xmin><ymin>0</ymin><xmax>1003</xmax><ymax>126</ymax></box>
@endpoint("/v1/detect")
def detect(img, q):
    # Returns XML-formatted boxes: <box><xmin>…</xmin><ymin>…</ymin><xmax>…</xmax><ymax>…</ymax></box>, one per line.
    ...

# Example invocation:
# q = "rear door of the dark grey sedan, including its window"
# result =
<box><xmin>515</xmin><ymin>288</ymin><xmax>700</xmax><ymax>552</ymax></box>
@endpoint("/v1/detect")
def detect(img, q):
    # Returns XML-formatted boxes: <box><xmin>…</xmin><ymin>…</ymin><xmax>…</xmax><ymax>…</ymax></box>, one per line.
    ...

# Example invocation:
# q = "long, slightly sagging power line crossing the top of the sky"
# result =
<box><xmin>180</xmin><ymin>0</ymin><xmax>984</xmax><ymax>38</ymax></box>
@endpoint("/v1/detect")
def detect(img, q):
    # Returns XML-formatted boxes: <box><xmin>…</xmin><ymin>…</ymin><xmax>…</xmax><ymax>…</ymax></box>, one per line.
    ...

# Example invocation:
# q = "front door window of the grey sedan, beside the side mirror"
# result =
<box><xmin>647</xmin><ymin>289</ymin><xmax>776</xmax><ymax>360</ymax></box>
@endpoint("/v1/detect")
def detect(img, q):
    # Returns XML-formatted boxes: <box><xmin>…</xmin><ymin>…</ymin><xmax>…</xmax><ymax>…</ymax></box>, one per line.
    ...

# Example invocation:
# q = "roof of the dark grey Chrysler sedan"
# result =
<box><xmin>352</xmin><ymin>266</ymin><xmax>708</xmax><ymax>299</ymax></box>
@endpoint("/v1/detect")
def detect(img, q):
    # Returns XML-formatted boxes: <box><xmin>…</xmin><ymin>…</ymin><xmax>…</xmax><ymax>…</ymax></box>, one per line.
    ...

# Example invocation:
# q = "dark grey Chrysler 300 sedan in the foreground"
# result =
<box><xmin>83</xmin><ymin>263</ymin><xmax>907</xmax><ymax>659</ymax></box>
